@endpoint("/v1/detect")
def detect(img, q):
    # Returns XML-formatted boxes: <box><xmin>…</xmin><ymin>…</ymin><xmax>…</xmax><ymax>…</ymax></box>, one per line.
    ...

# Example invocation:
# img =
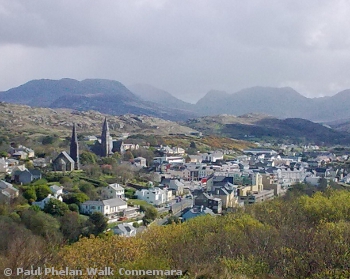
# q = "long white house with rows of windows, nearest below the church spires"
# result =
<box><xmin>80</xmin><ymin>198</ymin><xmax>128</xmax><ymax>216</ymax></box>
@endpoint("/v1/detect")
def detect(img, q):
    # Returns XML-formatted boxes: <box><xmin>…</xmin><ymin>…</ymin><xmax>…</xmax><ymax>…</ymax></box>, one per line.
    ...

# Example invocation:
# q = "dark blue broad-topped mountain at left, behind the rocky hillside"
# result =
<box><xmin>0</xmin><ymin>79</ymin><xmax>195</xmax><ymax>120</ymax></box>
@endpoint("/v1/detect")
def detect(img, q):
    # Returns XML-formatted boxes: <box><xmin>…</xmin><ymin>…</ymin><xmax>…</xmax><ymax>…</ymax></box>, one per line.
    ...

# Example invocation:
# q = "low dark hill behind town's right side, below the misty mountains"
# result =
<box><xmin>184</xmin><ymin>114</ymin><xmax>350</xmax><ymax>145</ymax></box>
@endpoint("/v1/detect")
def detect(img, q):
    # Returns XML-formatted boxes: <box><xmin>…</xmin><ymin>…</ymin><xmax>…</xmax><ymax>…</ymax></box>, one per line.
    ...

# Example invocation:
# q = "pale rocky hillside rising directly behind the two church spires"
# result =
<box><xmin>0</xmin><ymin>102</ymin><xmax>198</xmax><ymax>139</ymax></box>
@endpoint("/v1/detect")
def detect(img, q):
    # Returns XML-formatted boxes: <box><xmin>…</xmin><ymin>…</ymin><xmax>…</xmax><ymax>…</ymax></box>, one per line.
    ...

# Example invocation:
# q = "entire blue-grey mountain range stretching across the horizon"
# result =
<box><xmin>0</xmin><ymin>78</ymin><xmax>350</xmax><ymax>122</ymax></box>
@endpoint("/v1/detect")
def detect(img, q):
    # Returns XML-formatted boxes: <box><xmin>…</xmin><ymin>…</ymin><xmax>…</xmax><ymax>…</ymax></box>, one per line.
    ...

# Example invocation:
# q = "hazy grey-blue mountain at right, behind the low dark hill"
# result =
<box><xmin>196</xmin><ymin>87</ymin><xmax>350</xmax><ymax>122</ymax></box>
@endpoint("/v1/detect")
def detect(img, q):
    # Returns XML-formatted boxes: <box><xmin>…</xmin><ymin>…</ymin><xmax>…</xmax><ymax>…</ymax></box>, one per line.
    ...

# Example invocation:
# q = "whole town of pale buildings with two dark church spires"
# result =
<box><xmin>0</xmin><ymin>118</ymin><xmax>350</xmax><ymax>241</ymax></box>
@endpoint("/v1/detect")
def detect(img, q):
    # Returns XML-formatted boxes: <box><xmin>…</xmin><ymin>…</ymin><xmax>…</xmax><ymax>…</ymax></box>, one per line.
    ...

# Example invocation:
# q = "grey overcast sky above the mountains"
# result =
<box><xmin>0</xmin><ymin>0</ymin><xmax>350</xmax><ymax>102</ymax></box>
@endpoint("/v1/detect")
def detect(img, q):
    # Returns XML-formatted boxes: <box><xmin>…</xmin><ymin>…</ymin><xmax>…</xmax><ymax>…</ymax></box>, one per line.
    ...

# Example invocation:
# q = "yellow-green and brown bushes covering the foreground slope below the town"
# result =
<box><xmin>3</xmin><ymin>190</ymin><xmax>350</xmax><ymax>278</ymax></box>
